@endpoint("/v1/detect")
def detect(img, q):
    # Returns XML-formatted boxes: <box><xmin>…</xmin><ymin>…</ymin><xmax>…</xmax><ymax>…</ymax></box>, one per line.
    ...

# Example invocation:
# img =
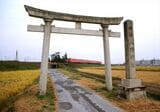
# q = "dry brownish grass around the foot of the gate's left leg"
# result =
<box><xmin>2</xmin><ymin>75</ymin><xmax>56</xmax><ymax>112</ymax></box>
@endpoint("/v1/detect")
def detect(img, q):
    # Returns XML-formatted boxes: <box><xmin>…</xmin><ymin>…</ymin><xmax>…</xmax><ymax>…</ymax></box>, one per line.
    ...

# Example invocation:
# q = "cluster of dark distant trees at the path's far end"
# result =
<box><xmin>50</xmin><ymin>52</ymin><xmax>67</xmax><ymax>63</ymax></box>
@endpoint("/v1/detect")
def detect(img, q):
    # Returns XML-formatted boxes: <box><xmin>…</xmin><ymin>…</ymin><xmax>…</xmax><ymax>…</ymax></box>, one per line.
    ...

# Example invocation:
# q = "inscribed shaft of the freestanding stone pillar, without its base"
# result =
<box><xmin>124</xmin><ymin>20</ymin><xmax>136</xmax><ymax>79</ymax></box>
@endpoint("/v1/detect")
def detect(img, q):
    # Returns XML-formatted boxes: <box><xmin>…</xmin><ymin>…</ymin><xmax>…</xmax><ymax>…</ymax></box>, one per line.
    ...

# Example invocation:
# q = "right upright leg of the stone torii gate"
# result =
<box><xmin>102</xmin><ymin>25</ymin><xmax>113</xmax><ymax>91</ymax></box>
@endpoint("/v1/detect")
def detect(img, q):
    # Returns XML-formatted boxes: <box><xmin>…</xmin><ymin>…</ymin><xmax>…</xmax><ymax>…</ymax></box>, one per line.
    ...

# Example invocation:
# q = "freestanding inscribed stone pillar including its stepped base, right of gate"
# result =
<box><xmin>120</xmin><ymin>20</ymin><xmax>146</xmax><ymax>99</ymax></box>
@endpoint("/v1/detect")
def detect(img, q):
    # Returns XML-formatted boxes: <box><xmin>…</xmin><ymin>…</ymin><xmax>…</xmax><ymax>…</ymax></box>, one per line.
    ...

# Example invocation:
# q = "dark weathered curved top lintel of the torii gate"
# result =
<box><xmin>24</xmin><ymin>5</ymin><xmax>123</xmax><ymax>25</ymax></box>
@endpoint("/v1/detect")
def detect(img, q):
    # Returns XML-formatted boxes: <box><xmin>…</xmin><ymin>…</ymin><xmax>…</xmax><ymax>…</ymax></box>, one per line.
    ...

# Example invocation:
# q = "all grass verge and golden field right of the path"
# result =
<box><xmin>59</xmin><ymin>64</ymin><xmax>160</xmax><ymax>112</ymax></box>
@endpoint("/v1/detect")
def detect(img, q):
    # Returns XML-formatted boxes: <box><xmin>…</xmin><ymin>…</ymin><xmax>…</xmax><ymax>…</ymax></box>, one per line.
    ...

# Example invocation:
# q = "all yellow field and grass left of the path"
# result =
<box><xmin>0</xmin><ymin>61</ymin><xmax>55</xmax><ymax>112</ymax></box>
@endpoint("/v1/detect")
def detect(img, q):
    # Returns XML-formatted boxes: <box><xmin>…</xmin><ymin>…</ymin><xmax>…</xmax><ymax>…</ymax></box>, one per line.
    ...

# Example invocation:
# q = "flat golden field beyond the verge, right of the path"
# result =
<box><xmin>77</xmin><ymin>67</ymin><xmax>160</xmax><ymax>96</ymax></box>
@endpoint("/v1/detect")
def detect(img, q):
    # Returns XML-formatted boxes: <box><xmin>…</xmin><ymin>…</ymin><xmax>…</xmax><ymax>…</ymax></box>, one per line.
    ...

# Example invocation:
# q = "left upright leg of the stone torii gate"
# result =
<box><xmin>39</xmin><ymin>19</ymin><xmax>52</xmax><ymax>95</ymax></box>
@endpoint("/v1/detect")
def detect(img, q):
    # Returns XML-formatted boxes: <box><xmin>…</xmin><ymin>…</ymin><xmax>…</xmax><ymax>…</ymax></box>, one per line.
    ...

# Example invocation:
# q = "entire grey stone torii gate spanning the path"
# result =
<box><xmin>25</xmin><ymin>5</ymin><xmax>123</xmax><ymax>95</ymax></box>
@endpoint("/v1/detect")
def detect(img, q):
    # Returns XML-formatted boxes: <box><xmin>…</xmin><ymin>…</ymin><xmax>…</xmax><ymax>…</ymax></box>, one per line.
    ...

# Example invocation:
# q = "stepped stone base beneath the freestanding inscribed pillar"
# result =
<box><xmin>119</xmin><ymin>79</ymin><xmax>146</xmax><ymax>100</ymax></box>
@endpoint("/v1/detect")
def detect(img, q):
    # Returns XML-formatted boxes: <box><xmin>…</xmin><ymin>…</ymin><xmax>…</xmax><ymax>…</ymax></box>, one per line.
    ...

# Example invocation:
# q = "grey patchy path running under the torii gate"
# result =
<box><xmin>49</xmin><ymin>69</ymin><xmax>123</xmax><ymax>112</ymax></box>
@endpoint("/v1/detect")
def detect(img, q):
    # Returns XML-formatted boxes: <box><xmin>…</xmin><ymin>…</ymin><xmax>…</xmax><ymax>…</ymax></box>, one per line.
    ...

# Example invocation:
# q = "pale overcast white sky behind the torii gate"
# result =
<box><xmin>0</xmin><ymin>0</ymin><xmax>160</xmax><ymax>63</ymax></box>
